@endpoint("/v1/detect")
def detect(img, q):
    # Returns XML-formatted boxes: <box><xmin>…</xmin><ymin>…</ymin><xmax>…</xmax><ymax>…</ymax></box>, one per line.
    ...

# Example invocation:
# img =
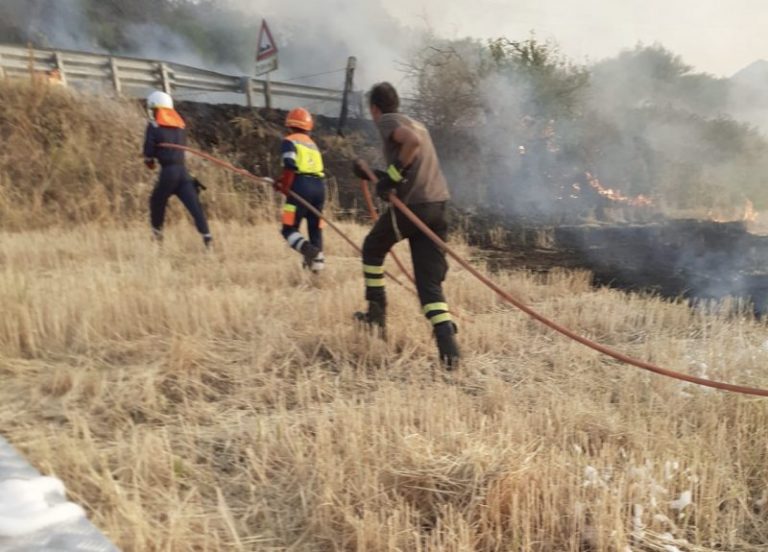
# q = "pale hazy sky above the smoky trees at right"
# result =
<box><xmin>386</xmin><ymin>0</ymin><xmax>768</xmax><ymax>77</ymax></box>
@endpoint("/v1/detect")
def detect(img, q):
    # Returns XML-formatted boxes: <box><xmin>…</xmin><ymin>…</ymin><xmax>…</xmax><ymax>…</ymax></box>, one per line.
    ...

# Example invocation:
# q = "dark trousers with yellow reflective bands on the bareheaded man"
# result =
<box><xmin>363</xmin><ymin>202</ymin><xmax>451</xmax><ymax>326</ymax></box>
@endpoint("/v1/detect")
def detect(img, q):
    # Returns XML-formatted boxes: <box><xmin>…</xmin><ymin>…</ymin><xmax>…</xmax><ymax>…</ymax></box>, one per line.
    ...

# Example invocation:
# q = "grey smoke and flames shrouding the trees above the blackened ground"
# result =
<box><xmin>426</xmin><ymin>38</ymin><xmax>768</xmax><ymax>219</ymax></box>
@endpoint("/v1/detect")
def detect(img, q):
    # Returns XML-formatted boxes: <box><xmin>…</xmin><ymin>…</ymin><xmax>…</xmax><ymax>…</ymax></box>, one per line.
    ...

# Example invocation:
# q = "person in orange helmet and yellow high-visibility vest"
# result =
<box><xmin>274</xmin><ymin>107</ymin><xmax>325</xmax><ymax>273</ymax></box>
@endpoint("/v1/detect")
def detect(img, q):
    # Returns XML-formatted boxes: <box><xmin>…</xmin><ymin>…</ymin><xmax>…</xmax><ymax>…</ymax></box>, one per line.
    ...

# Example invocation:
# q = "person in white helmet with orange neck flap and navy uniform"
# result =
<box><xmin>144</xmin><ymin>91</ymin><xmax>213</xmax><ymax>248</ymax></box>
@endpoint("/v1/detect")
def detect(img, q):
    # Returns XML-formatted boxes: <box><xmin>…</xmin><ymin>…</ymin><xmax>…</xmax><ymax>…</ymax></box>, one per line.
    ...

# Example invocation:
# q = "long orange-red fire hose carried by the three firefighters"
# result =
<box><xmin>160</xmin><ymin>144</ymin><xmax>768</xmax><ymax>397</ymax></box>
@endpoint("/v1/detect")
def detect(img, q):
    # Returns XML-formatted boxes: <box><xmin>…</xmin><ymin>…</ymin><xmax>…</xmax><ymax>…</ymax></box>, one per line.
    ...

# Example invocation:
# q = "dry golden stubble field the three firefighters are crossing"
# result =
<box><xmin>0</xmin><ymin>80</ymin><xmax>768</xmax><ymax>552</ymax></box>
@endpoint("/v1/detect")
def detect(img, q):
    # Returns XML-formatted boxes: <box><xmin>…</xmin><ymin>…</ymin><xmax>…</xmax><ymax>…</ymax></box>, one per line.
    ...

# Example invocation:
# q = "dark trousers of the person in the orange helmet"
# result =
<box><xmin>281</xmin><ymin>175</ymin><xmax>325</xmax><ymax>251</ymax></box>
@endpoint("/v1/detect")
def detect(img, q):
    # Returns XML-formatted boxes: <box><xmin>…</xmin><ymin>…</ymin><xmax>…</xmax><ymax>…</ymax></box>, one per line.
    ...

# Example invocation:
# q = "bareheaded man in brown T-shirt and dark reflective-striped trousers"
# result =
<box><xmin>355</xmin><ymin>82</ymin><xmax>459</xmax><ymax>370</ymax></box>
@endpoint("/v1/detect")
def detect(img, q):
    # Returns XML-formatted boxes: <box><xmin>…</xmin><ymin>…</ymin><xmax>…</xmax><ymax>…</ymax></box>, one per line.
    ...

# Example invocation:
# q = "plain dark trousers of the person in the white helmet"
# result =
<box><xmin>149</xmin><ymin>165</ymin><xmax>210</xmax><ymax>236</ymax></box>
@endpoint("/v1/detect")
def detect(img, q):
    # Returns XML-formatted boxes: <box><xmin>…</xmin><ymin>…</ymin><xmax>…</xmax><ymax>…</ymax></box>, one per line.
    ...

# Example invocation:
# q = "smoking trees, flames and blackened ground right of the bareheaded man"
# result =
<box><xmin>406</xmin><ymin>36</ymin><xmax>768</xmax><ymax>313</ymax></box>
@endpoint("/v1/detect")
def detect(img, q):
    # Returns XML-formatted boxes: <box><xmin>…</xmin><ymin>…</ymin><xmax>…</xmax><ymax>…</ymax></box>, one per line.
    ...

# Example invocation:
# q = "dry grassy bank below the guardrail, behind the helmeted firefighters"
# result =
<box><xmin>0</xmin><ymin>81</ymin><xmax>377</xmax><ymax>230</ymax></box>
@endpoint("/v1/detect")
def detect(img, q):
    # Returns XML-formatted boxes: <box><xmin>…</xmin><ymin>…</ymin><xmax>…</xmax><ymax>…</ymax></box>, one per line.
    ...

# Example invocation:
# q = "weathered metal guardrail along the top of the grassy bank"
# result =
<box><xmin>0</xmin><ymin>44</ymin><xmax>362</xmax><ymax>113</ymax></box>
